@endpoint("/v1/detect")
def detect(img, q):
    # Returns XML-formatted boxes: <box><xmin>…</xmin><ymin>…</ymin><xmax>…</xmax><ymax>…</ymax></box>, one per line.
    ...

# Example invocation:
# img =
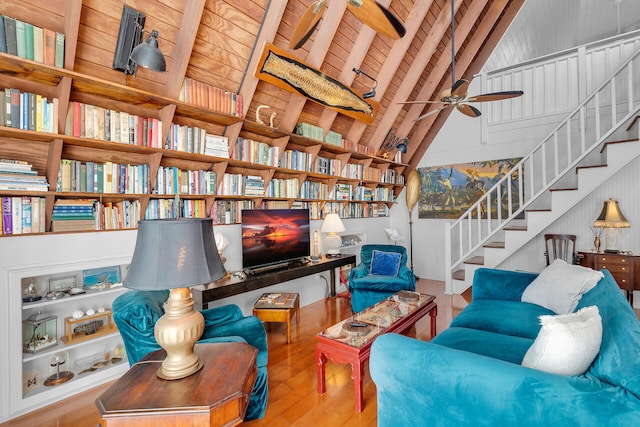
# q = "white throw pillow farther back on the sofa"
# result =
<box><xmin>521</xmin><ymin>259</ymin><xmax>604</xmax><ymax>314</ymax></box>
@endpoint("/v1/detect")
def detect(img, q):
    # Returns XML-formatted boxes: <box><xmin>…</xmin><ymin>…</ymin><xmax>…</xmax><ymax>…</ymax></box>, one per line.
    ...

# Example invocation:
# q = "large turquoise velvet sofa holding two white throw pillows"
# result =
<box><xmin>370</xmin><ymin>269</ymin><xmax>640</xmax><ymax>427</ymax></box>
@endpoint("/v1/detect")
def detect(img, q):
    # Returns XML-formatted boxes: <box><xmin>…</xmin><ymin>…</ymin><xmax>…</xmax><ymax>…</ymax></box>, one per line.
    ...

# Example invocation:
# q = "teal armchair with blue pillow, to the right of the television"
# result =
<box><xmin>349</xmin><ymin>244</ymin><xmax>416</xmax><ymax>313</ymax></box>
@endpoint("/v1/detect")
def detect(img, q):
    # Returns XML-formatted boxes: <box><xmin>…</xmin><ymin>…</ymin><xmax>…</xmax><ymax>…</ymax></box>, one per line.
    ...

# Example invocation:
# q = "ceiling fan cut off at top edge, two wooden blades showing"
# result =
<box><xmin>289</xmin><ymin>0</ymin><xmax>406</xmax><ymax>49</ymax></box>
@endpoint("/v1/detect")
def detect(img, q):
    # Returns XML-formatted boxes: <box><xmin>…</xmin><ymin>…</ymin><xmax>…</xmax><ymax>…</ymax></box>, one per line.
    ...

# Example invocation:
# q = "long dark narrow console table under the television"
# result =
<box><xmin>191</xmin><ymin>255</ymin><xmax>356</xmax><ymax>310</ymax></box>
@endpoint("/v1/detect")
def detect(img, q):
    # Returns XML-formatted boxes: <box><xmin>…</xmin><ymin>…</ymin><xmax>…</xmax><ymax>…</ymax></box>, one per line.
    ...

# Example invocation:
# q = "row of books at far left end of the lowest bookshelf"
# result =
<box><xmin>0</xmin><ymin>196</ymin><xmax>46</xmax><ymax>235</ymax></box>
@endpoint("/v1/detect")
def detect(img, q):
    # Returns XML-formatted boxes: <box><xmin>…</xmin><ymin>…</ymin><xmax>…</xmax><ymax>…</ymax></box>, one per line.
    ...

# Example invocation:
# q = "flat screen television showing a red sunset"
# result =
<box><xmin>241</xmin><ymin>209</ymin><xmax>311</xmax><ymax>269</ymax></box>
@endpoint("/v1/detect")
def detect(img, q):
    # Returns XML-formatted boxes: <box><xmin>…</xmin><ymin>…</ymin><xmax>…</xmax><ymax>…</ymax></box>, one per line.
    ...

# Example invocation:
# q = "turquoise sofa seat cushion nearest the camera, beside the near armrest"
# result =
<box><xmin>431</xmin><ymin>326</ymin><xmax>533</xmax><ymax>364</ymax></box>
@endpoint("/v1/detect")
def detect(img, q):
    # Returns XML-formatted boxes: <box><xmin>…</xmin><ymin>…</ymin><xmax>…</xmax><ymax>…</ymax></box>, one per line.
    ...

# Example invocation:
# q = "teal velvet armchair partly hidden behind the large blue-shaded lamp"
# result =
<box><xmin>111</xmin><ymin>291</ymin><xmax>269</xmax><ymax>420</ymax></box>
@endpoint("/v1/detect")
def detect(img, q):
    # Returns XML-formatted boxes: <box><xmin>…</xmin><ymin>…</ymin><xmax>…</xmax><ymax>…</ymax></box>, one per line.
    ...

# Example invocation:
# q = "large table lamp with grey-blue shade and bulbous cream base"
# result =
<box><xmin>124</xmin><ymin>218</ymin><xmax>227</xmax><ymax>380</ymax></box>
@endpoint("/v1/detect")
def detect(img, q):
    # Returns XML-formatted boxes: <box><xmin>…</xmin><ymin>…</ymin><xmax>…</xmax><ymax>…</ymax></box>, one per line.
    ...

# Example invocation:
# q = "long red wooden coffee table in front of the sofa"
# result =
<box><xmin>316</xmin><ymin>292</ymin><xmax>438</xmax><ymax>412</ymax></box>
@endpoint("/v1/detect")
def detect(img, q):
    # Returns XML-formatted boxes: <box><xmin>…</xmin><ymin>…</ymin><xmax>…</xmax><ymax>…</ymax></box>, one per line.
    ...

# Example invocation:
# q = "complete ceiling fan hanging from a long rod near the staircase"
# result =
<box><xmin>400</xmin><ymin>0</ymin><xmax>524</xmax><ymax>122</ymax></box>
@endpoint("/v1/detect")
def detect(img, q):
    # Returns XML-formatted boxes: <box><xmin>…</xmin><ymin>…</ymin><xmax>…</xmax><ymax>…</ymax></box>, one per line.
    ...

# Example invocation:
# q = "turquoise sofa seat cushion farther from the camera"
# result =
<box><xmin>451</xmin><ymin>299</ymin><xmax>554</xmax><ymax>340</ymax></box>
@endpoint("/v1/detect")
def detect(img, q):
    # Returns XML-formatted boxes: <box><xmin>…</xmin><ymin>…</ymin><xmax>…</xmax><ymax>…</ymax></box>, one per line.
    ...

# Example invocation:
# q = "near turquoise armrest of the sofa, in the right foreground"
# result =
<box><xmin>369</xmin><ymin>334</ymin><xmax>640</xmax><ymax>427</ymax></box>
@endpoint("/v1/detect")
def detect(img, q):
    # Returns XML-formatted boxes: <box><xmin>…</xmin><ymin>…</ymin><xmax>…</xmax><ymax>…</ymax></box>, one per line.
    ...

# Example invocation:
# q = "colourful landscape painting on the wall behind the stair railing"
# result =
<box><xmin>418</xmin><ymin>158</ymin><xmax>521</xmax><ymax>219</ymax></box>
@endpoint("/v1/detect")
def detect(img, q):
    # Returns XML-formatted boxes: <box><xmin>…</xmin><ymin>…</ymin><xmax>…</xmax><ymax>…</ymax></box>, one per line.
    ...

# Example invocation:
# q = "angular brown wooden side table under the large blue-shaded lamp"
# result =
<box><xmin>96</xmin><ymin>343</ymin><xmax>258</xmax><ymax>427</ymax></box>
